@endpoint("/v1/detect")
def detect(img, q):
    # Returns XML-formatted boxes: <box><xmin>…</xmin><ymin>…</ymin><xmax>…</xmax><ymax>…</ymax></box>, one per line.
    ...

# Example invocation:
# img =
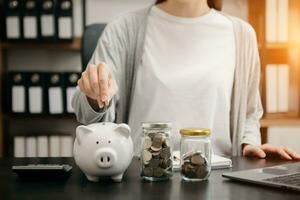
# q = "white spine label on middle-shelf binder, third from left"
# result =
<box><xmin>49</xmin><ymin>87</ymin><xmax>63</xmax><ymax>114</ymax></box>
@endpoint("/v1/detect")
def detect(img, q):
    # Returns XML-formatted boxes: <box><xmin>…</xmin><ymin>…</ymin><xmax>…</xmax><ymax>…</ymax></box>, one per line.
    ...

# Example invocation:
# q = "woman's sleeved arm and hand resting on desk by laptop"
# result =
<box><xmin>242</xmin><ymin>25</ymin><xmax>300</xmax><ymax>160</ymax></box>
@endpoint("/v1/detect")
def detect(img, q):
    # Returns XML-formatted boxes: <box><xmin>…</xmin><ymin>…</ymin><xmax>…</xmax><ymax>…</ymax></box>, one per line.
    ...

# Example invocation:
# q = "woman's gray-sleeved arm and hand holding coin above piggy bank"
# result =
<box><xmin>72</xmin><ymin>21</ymin><xmax>126</xmax><ymax>124</ymax></box>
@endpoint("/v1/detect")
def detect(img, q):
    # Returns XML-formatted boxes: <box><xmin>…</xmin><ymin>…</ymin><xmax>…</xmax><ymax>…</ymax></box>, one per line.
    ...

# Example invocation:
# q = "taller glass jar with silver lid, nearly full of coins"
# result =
<box><xmin>141</xmin><ymin>123</ymin><xmax>173</xmax><ymax>181</ymax></box>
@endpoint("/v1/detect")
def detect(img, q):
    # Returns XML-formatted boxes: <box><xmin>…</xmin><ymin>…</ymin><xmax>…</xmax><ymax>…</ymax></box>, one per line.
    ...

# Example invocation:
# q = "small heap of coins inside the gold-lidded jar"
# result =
<box><xmin>181</xmin><ymin>151</ymin><xmax>210</xmax><ymax>180</ymax></box>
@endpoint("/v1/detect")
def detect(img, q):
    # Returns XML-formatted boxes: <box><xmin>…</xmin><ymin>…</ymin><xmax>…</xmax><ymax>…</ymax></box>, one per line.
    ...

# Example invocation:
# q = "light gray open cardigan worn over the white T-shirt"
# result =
<box><xmin>72</xmin><ymin>7</ymin><xmax>263</xmax><ymax>155</ymax></box>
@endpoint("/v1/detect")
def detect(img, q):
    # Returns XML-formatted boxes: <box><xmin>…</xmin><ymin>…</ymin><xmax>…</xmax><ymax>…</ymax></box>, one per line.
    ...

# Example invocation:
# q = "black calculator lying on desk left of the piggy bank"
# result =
<box><xmin>12</xmin><ymin>164</ymin><xmax>72</xmax><ymax>180</ymax></box>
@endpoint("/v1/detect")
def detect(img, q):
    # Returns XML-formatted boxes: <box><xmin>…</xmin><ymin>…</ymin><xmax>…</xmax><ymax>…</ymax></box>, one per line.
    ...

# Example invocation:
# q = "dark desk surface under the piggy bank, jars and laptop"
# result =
<box><xmin>0</xmin><ymin>157</ymin><xmax>300</xmax><ymax>200</ymax></box>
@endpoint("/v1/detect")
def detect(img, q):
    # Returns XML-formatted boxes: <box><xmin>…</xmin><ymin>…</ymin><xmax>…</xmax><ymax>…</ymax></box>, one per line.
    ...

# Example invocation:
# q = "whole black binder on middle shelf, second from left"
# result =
<box><xmin>28</xmin><ymin>72</ymin><xmax>45</xmax><ymax>114</ymax></box>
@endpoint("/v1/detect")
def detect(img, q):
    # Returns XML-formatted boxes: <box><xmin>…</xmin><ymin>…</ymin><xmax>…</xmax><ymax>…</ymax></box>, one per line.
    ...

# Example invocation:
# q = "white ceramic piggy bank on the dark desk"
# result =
<box><xmin>73</xmin><ymin>122</ymin><xmax>133</xmax><ymax>182</ymax></box>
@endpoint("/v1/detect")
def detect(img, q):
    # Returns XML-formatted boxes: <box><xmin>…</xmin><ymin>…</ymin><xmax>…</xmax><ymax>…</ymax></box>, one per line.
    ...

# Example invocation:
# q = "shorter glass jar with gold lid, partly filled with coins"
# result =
<box><xmin>180</xmin><ymin>128</ymin><xmax>211</xmax><ymax>181</ymax></box>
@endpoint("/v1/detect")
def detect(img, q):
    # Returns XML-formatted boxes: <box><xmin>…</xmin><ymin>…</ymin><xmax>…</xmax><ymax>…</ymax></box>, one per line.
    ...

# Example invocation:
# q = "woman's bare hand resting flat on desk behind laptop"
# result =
<box><xmin>243</xmin><ymin>144</ymin><xmax>300</xmax><ymax>160</ymax></box>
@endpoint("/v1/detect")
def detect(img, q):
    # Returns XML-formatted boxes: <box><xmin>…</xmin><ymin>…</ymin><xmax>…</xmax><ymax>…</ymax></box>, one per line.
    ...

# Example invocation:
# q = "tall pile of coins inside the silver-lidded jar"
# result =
<box><xmin>141</xmin><ymin>133</ymin><xmax>172</xmax><ymax>179</ymax></box>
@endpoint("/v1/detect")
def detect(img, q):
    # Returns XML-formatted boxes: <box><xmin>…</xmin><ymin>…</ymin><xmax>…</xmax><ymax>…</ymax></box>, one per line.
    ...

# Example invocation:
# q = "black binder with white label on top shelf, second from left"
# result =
<box><xmin>23</xmin><ymin>0</ymin><xmax>39</xmax><ymax>40</ymax></box>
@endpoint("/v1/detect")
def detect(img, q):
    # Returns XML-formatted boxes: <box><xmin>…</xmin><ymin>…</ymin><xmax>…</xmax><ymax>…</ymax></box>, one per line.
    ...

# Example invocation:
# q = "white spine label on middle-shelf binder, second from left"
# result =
<box><xmin>28</xmin><ymin>86</ymin><xmax>43</xmax><ymax>113</ymax></box>
